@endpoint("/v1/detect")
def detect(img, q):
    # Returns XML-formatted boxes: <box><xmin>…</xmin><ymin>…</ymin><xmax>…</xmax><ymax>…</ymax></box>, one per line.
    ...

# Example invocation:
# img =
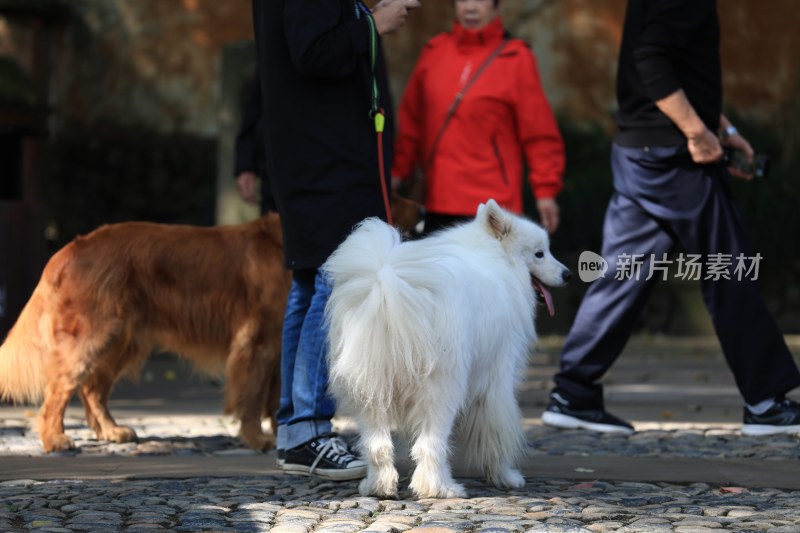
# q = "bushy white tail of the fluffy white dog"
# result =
<box><xmin>324</xmin><ymin>218</ymin><xmax>435</xmax><ymax>412</ymax></box>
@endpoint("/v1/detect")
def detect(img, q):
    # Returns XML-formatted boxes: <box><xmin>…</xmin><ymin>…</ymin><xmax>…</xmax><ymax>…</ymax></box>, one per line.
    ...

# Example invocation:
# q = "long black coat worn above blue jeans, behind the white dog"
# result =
<box><xmin>253</xmin><ymin>0</ymin><xmax>393</xmax><ymax>269</ymax></box>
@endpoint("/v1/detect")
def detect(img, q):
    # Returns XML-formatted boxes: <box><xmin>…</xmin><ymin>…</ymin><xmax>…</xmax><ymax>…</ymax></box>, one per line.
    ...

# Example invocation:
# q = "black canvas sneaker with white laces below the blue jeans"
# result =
<box><xmin>279</xmin><ymin>433</ymin><xmax>367</xmax><ymax>481</ymax></box>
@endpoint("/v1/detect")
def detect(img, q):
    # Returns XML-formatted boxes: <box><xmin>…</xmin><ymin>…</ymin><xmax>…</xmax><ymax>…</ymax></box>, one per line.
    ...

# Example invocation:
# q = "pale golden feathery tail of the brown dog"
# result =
<box><xmin>0</xmin><ymin>287</ymin><xmax>46</xmax><ymax>403</ymax></box>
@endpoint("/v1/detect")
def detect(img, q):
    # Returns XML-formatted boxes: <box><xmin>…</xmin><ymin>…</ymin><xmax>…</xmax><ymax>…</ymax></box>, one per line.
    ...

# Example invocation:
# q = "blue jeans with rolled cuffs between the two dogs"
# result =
<box><xmin>277</xmin><ymin>271</ymin><xmax>336</xmax><ymax>450</ymax></box>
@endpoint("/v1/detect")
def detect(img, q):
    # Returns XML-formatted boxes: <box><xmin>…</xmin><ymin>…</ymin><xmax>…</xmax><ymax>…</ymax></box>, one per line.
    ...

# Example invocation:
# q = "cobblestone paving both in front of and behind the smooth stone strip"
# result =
<box><xmin>0</xmin><ymin>415</ymin><xmax>800</xmax><ymax>533</ymax></box>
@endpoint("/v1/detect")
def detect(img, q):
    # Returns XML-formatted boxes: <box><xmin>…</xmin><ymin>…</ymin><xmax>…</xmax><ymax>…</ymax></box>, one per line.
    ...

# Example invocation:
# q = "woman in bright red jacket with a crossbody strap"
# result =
<box><xmin>392</xmin><ymin>0</ymin><xmax>564</xmax><ymax>233</ymax></box>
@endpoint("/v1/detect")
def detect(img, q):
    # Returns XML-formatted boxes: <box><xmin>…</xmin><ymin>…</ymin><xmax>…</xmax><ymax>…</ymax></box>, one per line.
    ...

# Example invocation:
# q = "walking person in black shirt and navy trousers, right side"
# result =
<box><xmin>542</xmin><ymin>0</ymin><xmax>800</xmax><ymax>435</ymax></box>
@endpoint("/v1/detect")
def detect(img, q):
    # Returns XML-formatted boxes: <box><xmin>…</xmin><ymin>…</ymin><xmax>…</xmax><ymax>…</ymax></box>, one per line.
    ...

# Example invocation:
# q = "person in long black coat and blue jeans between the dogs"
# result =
<box><xmin>253</xmin><ymin>0</ymin><xmax>420</xmax><ymax>480</ymax></box>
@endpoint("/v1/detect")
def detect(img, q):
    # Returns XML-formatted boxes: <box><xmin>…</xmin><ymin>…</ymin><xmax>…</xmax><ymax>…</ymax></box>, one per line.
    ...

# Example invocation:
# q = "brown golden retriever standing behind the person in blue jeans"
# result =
<box><xmin>0</xmin><ymin>214</ymin><xmax>291</xmax><ymax>452</ymax></box>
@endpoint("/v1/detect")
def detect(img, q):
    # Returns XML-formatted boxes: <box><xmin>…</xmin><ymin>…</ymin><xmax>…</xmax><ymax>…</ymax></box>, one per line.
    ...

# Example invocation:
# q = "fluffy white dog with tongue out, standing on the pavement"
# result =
<box><xmin>324</xmin><ymin>200</ymin><xmax>570</xmax><ymax>498</ymax></box>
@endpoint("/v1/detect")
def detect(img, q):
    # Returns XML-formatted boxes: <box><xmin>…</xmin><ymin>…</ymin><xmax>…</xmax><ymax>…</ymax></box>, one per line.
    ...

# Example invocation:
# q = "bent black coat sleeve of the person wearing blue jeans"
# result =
<box><xmin>283</xmin><ymin>0</ymin><xmax>370</xmax><ymax>77</ymax></box>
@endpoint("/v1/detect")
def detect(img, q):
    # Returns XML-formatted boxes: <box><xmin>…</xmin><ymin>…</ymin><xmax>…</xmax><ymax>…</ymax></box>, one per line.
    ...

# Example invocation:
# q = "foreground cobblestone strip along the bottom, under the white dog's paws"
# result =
<box><xmin>6</xmin><ymin>475</ymin><xmax>800</xmax><ymax>533</ymax></box>
